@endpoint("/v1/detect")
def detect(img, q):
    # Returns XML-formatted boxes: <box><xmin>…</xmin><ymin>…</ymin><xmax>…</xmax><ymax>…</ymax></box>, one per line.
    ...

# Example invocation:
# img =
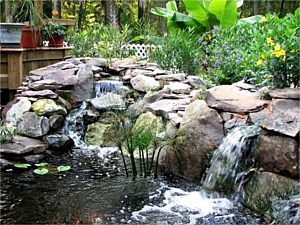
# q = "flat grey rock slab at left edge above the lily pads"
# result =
<box><xmin>0</xmin><ymin>136</ymin><xmax>48</xmax><ymax>155</ymax></box>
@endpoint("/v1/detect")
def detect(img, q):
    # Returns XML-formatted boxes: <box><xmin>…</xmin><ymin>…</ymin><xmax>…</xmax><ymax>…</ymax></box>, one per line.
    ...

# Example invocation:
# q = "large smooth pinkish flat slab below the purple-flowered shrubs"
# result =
<box><xmin>206</xmin><ymin>85</ymin><xmax>269</xmax><ymax>112</ymax></box>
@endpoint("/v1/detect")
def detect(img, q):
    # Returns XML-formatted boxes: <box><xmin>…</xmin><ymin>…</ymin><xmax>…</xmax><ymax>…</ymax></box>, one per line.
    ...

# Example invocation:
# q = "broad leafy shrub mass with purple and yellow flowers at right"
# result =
<box><xmin>201</xmin><ymin>9</ymin><xmax>300</xmax><ymax>87</ymax></box>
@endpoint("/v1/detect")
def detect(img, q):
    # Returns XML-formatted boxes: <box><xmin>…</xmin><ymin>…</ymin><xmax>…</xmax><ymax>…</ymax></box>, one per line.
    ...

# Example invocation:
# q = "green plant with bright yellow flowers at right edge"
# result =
<box><xmin>256</xmin><ymin>9</ymin><xmax>300</xmax><ymax>87</ymax></box>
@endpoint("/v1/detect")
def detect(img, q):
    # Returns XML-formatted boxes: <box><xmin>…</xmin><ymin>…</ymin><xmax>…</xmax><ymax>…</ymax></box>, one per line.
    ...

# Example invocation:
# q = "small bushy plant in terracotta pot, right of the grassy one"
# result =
<box><xmin>44</xmin><ymin>21</ymin><xmax>67</xmax><ymax>47</ymax></box>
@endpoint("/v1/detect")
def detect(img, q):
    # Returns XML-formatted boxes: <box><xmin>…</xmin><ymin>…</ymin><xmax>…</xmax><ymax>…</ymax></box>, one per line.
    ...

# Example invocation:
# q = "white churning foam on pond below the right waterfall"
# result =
<box><xmin>132</xmin><ymin>186</ymin><xmax>233</xmax><ymax>224</ymax></box>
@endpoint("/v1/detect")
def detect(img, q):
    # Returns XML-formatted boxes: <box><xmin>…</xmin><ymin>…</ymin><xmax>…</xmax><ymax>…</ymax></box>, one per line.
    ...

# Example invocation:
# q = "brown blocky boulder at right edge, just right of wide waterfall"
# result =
<box><xmin>256</xmin><ymin>134</ymin><xmax>300</xmax><ymax>178</ymax></box>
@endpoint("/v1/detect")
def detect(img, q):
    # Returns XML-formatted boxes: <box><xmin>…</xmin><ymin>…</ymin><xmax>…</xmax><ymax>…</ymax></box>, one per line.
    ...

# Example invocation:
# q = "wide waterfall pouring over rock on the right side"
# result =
<box><xmin>203</xmin><ymin>125</ymin><xmax>260</xmax><ymax>191</ymax></box>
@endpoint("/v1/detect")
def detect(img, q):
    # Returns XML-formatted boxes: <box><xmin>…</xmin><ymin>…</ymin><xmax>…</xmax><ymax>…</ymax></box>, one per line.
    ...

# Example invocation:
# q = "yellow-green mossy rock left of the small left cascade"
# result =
<box><xmin>31</xmin><ymin>99</ymin><xmax>67</xmax><ymax>116</ymax></box>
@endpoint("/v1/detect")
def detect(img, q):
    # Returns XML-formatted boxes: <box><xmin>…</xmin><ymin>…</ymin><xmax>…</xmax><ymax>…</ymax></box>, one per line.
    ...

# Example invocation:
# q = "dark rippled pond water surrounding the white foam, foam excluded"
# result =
<box><xmin>1</xmin><ymin>152</ymin><xmax>262</xmax><ymax>224</ymax></box>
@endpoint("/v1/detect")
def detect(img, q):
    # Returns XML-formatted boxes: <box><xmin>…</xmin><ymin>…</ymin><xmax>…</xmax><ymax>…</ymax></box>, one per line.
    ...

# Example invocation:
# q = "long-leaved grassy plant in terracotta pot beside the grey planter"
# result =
<box><xmin>15</xmin><ymin>0</ymin><xmax>43</xmax><ymax>48</ymax></box>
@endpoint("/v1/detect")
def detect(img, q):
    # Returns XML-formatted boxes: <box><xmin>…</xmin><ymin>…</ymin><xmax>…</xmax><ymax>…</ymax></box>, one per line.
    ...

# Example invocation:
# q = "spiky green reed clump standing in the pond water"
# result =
<box><xmin>106</xmin><ymin>109</ymin><xmax>173</xmax><ymax>179</ymax></box>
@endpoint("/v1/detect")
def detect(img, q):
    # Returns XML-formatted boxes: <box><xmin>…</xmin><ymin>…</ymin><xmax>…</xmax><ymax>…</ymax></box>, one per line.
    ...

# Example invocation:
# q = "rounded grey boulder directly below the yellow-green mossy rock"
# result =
<box><xmin>17</xmin><ymin>112</ymin><xmax>50</xmax><ymax>138</ymax></box>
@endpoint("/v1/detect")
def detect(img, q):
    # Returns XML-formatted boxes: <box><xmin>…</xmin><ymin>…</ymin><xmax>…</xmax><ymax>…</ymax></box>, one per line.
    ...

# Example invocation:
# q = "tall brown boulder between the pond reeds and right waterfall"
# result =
<box><xmin>160</xmin><ymin>100</ymin><xmax>224</xmax><ymax>180</ymax></box>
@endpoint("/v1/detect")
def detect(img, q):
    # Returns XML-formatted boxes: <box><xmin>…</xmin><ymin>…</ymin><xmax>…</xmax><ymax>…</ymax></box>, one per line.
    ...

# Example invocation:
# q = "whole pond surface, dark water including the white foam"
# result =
<box><xmin>0</xmin><ymin>151</ymin><xmax>264</xmax><ymax>225</ymax></box>
